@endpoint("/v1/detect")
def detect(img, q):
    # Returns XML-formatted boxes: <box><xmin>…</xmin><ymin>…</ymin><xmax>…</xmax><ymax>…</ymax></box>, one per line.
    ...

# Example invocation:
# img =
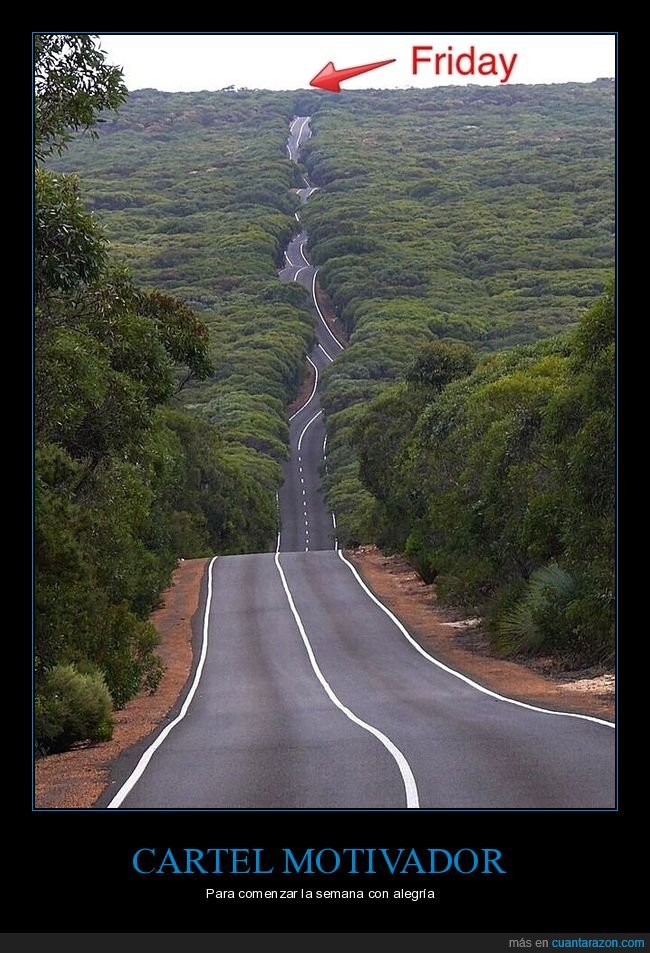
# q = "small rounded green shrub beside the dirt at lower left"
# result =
<box><xmin>35</xmin><ymin>664</ymin><xmax>113</xmax><ymax>753</ymax></box>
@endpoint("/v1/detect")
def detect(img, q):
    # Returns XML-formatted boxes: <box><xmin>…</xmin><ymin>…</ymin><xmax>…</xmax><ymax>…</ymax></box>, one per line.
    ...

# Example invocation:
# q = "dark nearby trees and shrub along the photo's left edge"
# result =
<box><xmin>34</xmin><ymin>34</ymin><xmax>211</xmax><ymax>751</ymax></box>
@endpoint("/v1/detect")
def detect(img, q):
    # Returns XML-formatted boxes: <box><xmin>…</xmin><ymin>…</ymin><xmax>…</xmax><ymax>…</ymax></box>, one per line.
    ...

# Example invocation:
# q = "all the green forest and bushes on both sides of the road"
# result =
<box><xmin>35</xmin><ymin>34</ymin><xmax>614</xmax><ymax>752</ymax></box>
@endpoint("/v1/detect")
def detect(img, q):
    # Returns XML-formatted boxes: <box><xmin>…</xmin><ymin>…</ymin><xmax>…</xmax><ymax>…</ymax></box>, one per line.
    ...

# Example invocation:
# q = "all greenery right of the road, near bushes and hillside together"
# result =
<box><xmin>302</xmin><ymin>80</ymin><xmax>615</xmax><ymax>665</ymax></box>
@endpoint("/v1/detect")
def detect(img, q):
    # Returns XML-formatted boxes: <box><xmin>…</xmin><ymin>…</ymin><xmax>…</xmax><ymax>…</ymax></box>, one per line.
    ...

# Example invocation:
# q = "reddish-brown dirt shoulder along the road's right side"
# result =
<box><xmin>346</xmin><ymin>546</ymin><xmax>615</xmax><ymax>721</ymax></box>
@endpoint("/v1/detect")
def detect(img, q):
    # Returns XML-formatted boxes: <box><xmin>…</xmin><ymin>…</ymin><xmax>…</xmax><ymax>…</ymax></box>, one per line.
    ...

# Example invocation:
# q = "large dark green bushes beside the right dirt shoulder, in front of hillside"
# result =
<box><xmin>354</xmin><ymin>290</ymin><xmax>615</xmax><ymax>662</ymax></box>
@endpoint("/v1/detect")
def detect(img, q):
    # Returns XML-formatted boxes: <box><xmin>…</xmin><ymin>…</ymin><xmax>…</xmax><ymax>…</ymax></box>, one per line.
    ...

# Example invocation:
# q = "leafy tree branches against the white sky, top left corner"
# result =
<box><xmin>34</xmin><ymin>33</ymin><xmax>127</xmax><ymax>162</ymax></box>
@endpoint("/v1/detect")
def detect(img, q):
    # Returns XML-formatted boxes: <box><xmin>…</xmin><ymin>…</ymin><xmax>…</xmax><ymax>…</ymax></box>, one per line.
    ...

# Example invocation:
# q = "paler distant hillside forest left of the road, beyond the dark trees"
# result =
<box><xmin>51</xmin><ymin>90</ymin><xmax>313</xmax><ymax>536</ymax></box>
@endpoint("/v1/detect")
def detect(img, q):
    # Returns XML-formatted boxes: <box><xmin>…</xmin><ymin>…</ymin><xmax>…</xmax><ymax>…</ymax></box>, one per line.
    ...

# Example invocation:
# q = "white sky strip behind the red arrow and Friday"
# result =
<box><xmin>100</xmin><ymin>33</ymin><xmax>616</xmax><ymax>91</ymax></box>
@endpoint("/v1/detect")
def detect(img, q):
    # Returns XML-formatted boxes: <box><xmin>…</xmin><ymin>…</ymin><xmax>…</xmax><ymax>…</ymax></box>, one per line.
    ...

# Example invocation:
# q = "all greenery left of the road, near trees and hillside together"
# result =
<box><xmin>35</xmin><ymin>34</ymin><xmax>313</xmax><ymax>752</ymax></box>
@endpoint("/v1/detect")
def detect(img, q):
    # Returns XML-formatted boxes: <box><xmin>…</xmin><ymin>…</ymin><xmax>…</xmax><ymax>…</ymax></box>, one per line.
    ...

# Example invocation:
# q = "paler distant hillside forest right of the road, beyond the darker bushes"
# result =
<box><xmin>300</xmin><ymin>80</ymin><xmax>614</xmax><ymax>556</ymax></box>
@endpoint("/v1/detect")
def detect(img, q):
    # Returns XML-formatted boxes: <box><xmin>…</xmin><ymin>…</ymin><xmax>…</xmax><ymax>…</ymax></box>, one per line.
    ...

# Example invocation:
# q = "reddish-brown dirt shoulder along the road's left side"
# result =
<box><xmin>34</xmin><ymin>559</ymin><xmax>208</xmax><ymax>809</ymax></box>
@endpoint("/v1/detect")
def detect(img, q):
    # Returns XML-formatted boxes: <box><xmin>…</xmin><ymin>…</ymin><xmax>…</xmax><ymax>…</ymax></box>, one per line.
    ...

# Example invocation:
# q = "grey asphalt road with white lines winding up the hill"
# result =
<box><xmin>97</xmin><ymin>116</ymin><xmax>615</xmax><ymax>810</ymax></box>
